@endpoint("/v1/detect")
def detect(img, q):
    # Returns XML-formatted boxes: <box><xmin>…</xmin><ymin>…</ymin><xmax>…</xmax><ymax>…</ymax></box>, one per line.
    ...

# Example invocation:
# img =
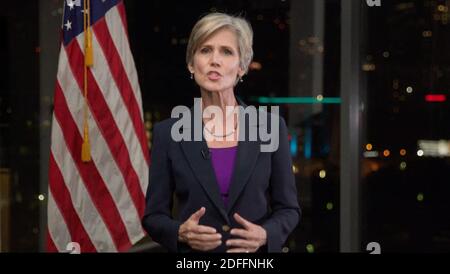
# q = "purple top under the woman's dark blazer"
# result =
<box><xmin>209</xmin><ymin>146</ymin><xmax>237</xmax><ymax>206</ymax></box>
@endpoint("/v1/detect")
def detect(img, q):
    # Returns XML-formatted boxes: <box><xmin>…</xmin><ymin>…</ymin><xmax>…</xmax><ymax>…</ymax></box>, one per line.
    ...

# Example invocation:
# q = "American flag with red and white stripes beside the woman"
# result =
<box><xmin>47</xmin><ymin>0</ymin><xmax>149</xmax><ymax>252</ymax></box>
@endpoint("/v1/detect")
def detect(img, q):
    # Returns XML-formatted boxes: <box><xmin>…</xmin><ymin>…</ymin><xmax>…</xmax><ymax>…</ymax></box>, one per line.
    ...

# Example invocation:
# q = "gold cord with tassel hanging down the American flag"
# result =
<box><xmin>81</xmin><ymin>0</ymin><xmax>94</xmax><ymax>163</ymax></box>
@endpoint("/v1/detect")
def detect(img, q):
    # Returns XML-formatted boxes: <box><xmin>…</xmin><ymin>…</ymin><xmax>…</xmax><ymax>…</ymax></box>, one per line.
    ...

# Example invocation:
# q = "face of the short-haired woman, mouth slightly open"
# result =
<box><xmin>189</xmin><ymin>28</ymin><xmax>244</xmax><ymax>92</ymax></box>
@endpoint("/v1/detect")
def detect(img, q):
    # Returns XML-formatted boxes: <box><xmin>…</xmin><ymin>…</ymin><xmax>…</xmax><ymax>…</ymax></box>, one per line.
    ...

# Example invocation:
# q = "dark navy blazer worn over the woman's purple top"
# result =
<box><xmin>142</xmin><ymin>101</ymin><xmax>301</xmax><ymax>252</ymax></box>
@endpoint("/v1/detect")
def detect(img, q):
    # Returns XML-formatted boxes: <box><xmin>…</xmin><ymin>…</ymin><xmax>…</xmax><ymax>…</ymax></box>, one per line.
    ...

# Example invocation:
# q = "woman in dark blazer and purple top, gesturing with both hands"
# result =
<box><xmin>142</xmin><ymin>13</ymin><xmax>300</xmax><ymax>252</ymax></box>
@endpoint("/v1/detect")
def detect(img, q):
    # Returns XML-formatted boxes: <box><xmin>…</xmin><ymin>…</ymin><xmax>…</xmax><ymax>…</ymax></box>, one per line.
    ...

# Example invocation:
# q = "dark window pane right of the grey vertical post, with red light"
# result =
<box><xmin>361</xmin><ymin>0</ymin><xmax>450</xmax><ymax>252</ymax></box>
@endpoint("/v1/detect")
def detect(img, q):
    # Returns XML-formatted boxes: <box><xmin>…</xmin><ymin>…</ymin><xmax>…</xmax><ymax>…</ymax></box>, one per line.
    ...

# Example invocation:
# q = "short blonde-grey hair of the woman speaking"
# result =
<box><xmin>186</xmin><ymin>12</ymin><xmax>253</xmax><ymax>73</ymax></box>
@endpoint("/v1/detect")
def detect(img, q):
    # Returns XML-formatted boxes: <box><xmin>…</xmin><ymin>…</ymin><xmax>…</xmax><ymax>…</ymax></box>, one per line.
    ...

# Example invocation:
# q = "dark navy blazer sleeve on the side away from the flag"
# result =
<box><xmin>262</xmin><ymin>117</ymin><xmax>301</xmax><ymax>252</ymax></box>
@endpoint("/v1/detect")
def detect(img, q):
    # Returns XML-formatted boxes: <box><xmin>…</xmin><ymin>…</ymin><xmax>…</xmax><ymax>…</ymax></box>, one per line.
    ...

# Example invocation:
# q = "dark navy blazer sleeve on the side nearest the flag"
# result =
<box><xmin>142</xmin><ymin>124</ymin><xmax>181</xmax><ymax>252</ymax></box>
